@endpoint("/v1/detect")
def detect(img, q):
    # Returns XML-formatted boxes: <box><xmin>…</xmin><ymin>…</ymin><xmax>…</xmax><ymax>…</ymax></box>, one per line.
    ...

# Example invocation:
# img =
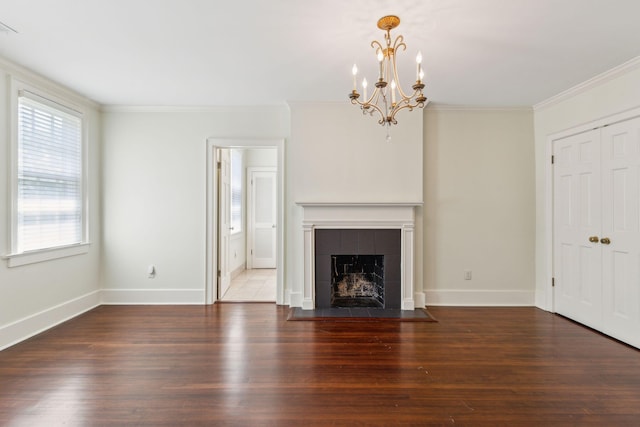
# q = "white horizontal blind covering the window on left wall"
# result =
<box><xmin>15</xmin><ymin>93</ymin><xmax>83</xmax><ymax>253</ymax></box>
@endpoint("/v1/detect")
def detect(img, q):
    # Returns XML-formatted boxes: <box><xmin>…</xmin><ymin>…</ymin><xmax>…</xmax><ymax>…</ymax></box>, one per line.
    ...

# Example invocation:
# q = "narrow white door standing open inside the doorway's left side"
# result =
<box><xmin>218</xmin><ymin>148</ymin><xmax>231</xmax><ymax>298</ymax></box>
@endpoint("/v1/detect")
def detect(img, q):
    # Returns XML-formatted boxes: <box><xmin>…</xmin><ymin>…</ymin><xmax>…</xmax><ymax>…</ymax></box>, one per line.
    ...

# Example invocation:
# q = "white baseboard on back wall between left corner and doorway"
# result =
<box><xmin>102</xmin><ymin>289</ymin><xmax>205</xmax><ymax>305</ymax></box>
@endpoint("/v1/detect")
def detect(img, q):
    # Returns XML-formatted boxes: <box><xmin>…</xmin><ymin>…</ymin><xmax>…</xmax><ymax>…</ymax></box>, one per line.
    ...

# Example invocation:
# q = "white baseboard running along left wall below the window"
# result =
<box><xmin>0</xmin><ymin>291</ymin><xmax>100</xmax><ymax>350</ymax></box>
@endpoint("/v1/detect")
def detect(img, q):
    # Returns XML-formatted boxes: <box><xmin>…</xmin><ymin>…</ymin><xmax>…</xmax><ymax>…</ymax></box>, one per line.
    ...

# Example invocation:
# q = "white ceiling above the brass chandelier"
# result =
<box><xmin>0</xmin><ymin>0</ymin><xmax>640</xmax><ymax>106</ymax></box>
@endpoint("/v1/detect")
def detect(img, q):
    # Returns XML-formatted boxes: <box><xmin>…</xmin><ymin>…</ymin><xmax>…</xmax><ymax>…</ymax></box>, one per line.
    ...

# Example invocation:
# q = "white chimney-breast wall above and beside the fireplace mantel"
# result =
<box><xmin>285</xmin><ymin>102</ymin><xmax>423</xmax><ymax>306</ymax></box>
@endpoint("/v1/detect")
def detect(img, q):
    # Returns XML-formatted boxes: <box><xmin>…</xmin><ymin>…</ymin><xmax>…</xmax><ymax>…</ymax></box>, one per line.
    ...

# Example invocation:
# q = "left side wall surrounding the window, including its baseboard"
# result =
<box><xmin>0</xmin><ymin>59</ymin><xmax>101</xmax><ymax>349</ymax></box>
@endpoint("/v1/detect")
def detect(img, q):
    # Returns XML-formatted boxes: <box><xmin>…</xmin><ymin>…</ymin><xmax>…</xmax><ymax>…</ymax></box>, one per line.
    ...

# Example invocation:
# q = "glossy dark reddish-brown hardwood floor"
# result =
<box><xmin>0</xmin><ymin>304</ymin><xmax>640</xmax><ymax>426</ymax></box>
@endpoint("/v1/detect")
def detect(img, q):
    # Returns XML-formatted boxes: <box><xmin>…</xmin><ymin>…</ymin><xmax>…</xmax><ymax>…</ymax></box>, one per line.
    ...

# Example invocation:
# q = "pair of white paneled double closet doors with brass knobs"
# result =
<box><xmin>553</xmin><ymin>118</ymin><xmax>640</xmax><ymax>347</ymax></box>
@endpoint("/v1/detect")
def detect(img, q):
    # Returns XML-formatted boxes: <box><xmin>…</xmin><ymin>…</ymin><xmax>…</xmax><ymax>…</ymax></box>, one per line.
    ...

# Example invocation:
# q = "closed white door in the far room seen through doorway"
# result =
<box><xmin>247</xmin><ymin>168</ymin><xmax>277</xmax><ymax>268</ymax></box>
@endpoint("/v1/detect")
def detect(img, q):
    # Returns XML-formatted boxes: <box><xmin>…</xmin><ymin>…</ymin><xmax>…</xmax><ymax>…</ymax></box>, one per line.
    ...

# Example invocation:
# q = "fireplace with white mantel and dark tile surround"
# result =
<box><xmin>298</xmin><ymin>202</ymin><xmax>425</xmax><ymax>310</ymax></box>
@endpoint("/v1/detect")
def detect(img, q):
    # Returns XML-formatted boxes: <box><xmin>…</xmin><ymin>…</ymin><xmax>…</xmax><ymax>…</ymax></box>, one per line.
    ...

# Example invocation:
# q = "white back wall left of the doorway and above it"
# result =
<box><xmin>102</xmin><ymin>106</ymin><xmax>289</xmax><ymax>304</ymax></box>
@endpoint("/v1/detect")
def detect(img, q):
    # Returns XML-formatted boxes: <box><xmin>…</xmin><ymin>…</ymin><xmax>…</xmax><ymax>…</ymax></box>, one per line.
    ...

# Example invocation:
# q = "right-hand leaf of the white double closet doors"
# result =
<box><xmin>600</xmin><ymin>119</ymin><xmax>640</xmax><ymax>347</ymax></box>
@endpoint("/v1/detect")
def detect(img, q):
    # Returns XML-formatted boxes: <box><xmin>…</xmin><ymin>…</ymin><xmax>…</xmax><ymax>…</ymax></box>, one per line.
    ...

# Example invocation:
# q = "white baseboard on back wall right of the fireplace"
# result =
<box><xmin>425</xmin><ymin>290</ymin><xmax>535</xmax><ymax>307</ymax></box>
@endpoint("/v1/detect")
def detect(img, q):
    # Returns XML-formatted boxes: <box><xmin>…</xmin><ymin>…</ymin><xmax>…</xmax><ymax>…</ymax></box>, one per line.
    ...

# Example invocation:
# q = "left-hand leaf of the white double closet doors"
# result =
<box><xmin>553</xmin><ymin>130</ymin><xmax>602</xmax><ymax>328</ymax></box>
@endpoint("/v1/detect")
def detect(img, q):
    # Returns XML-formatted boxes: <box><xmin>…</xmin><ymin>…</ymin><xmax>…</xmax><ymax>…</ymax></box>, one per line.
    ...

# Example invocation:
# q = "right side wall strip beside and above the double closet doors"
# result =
<box><xmin>534</xmin><ymin>58</ymin><xmax>640</xmax><ymax>310</ymax></box>
